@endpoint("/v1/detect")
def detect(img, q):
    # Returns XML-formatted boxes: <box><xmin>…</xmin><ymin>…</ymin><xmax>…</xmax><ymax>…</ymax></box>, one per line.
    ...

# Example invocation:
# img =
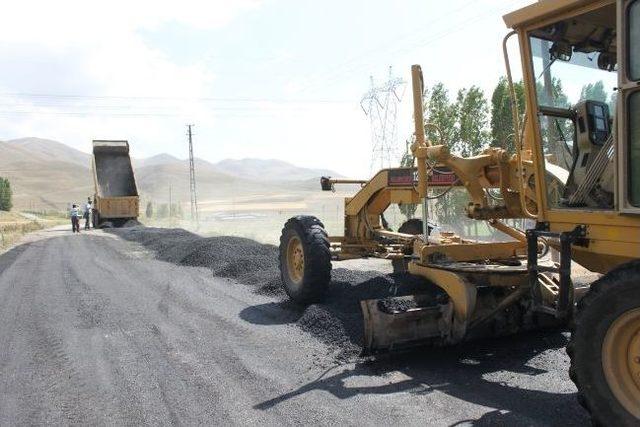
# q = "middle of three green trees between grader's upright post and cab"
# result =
<box><xmin>452</xmin><ymin>86</ymin><xmax>489</xmax><ymax>157</ymax></box>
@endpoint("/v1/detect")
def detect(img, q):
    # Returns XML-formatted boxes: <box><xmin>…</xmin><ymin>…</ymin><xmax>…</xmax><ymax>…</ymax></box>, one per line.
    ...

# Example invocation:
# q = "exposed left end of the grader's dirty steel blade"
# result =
<box><xmin>360</xmin><ymin>295</ymin><xmax>453</xmax><ymax>355</ymax></box>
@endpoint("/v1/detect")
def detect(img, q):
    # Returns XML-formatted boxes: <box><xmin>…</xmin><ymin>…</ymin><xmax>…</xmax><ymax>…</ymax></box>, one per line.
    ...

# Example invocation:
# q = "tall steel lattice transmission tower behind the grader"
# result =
<box><xmin>360</xmin><ymin>67</ymin><xmax>406</xmax><ymax>173</ymax></box>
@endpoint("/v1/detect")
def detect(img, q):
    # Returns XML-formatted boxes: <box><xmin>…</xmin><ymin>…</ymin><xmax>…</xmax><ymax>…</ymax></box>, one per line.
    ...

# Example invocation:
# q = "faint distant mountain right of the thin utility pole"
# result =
<box><xmin>213</xmin><ymin>159</ymin><xmax>341</xmax><ymax>182</ymax></box>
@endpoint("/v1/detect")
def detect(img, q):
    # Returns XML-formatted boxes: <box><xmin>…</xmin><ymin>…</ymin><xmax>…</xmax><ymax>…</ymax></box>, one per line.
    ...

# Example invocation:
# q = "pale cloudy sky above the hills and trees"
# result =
<box><xmin>0</xmin><ymin>0</ymin><xmax>532</xmax><ymax>177</ymax></box>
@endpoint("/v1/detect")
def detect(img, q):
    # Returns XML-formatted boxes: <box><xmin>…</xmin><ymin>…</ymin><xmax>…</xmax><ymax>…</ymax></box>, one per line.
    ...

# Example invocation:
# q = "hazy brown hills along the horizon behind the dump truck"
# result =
<box><xmin>0</xmin><ymin>138</ymin><xmax>339</xmax><ymax>209</ymax></box>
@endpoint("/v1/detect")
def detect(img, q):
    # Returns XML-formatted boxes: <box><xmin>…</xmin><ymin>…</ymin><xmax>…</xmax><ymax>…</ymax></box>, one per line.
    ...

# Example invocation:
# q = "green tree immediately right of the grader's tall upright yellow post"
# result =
<box><xmin>425</xmin><ymin>83</ymin><xmax>456</xmax><ymax>146</ymax></box>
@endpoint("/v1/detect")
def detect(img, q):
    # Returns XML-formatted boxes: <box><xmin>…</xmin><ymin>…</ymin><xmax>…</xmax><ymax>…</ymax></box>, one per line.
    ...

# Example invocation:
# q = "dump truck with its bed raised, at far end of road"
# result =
<box><xmin>92</xmin><ymin>140</ymin><xmax>140</xmax><ymax>228</ymax></box>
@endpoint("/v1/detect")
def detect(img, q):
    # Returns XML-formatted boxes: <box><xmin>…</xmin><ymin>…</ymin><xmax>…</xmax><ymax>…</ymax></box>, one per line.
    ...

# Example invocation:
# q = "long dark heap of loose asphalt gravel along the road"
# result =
<box><xmin>109</xmin><ymin>227</ymin><xmax>441</xmax><ymax>360</ymax></box>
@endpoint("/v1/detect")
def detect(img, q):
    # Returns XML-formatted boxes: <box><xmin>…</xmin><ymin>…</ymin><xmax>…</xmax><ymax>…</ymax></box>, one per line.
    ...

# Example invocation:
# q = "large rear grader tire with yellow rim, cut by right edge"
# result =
<box><xmin>567</xmin><ymin>260</ymin><xmax>640</xmax><ymax>426</ymax></box>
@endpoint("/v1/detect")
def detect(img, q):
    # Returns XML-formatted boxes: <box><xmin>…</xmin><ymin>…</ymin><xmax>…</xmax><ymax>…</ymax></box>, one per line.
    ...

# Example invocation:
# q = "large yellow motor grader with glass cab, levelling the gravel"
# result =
<box><xmin>280</xmin><ymin>0</ymin><xmax>640</xmax><ymax>425</ymax></box>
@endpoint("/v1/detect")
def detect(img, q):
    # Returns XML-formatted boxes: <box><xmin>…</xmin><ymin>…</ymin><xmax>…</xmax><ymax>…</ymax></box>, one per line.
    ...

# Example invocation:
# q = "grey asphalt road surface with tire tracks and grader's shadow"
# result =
<box><xmin>0</xmin><ymin>231</ymin><xmax>589</xmax><ymax>426</ymax></box>
